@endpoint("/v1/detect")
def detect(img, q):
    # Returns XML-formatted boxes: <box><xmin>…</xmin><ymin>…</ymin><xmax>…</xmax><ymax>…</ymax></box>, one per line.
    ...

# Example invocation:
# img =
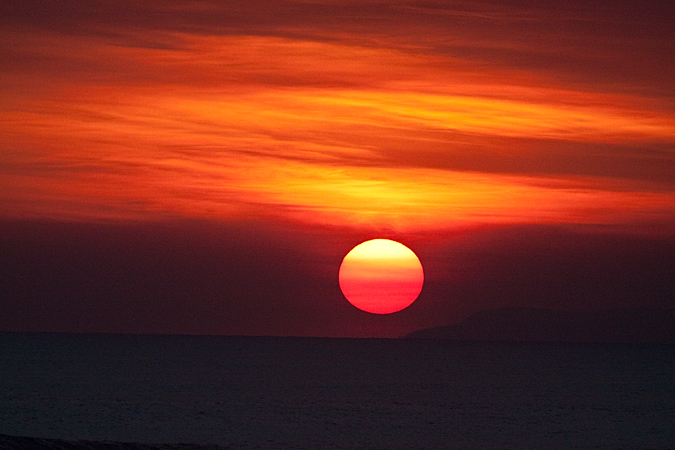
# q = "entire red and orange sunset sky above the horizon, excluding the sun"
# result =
<box><xmin>0</xmin><ymin>0</ymin><xmax>675</xmax><ymax>336</ymax></box>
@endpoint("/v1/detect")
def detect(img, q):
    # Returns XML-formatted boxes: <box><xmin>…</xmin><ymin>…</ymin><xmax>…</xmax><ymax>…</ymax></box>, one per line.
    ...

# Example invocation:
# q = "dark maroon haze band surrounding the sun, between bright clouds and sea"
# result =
<box><xmin>0</xmin><ymin>221</ymin><xmax>675</xmax><ymax>337</ymax></box>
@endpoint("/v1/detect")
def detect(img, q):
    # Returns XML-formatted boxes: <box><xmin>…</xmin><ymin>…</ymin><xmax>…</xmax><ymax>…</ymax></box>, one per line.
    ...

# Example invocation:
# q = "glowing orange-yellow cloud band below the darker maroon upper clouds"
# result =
<box><xmin>0</xmin><ymin>12</ymin><xmax>675</xmax><ymax>234</ymax></box>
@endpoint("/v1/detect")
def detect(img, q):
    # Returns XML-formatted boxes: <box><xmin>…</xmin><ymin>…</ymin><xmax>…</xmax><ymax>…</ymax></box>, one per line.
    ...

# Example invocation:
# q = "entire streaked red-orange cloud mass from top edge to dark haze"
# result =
<box><xmin>0</xmin><ymin>2</ymin><xmax>675</xmax><ymax>229</ymax></box>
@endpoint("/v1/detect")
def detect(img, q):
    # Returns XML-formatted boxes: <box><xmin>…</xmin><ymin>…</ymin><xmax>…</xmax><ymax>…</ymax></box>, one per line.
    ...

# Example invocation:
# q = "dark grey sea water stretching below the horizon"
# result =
<box><xmin>0</xmin><ymin>333</ymin><xmax>675</xmax><ymax>449</ymax></box>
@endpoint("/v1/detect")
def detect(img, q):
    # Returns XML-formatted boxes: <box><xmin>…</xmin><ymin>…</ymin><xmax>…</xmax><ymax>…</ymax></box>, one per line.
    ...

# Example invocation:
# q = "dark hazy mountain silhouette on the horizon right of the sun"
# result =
<box><xmin>406</xmin><ymin>308</ymin><xmax>675</xmax><ymax>344</ymax></box>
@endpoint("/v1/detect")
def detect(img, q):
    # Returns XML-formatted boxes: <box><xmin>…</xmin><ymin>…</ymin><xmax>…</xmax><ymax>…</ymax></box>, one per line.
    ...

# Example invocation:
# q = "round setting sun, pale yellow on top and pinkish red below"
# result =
<box><xmin>338</xmin><ymin>239</ymin><xmax>424</xmax><ymax>314</ymax></box>
